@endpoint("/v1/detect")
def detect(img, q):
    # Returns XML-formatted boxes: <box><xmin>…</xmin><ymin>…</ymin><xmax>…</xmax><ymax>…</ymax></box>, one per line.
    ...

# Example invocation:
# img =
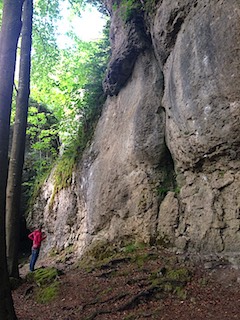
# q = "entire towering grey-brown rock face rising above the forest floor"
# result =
<box><xmin>33</xmin><ymin>0</ymin><xmax>240</xmax><ymax>254</ymax></box>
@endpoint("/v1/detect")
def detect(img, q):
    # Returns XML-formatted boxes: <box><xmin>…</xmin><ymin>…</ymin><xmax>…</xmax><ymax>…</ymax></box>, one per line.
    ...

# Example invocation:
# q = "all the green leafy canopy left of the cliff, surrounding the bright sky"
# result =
<box><xmin>0</xmin><ymin>0</ymin><xmax>110</xmax><ymax>208</ymax></box>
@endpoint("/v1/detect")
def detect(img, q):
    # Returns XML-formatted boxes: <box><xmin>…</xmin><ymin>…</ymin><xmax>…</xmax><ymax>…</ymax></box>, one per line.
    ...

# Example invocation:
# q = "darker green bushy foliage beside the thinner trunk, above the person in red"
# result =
<box><xmin>22</xmin><ymin>100</ymin><xmax>58</xmax><ymax>211</ymax></box>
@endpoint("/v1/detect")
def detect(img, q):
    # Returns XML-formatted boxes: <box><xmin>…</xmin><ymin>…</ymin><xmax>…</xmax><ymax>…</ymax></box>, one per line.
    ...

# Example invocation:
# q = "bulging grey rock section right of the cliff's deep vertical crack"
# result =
<box><xmin>152</xmin><ymin>1</ymin><xmax>240</xmax><ymax>252</ymax></box>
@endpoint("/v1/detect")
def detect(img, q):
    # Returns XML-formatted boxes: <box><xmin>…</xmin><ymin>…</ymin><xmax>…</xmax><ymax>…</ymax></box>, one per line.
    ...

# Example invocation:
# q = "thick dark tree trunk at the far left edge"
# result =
<box><xmin>0</xmin><ymin>0</ymin><xmax>23</xmax><ymax>320</ymax></box>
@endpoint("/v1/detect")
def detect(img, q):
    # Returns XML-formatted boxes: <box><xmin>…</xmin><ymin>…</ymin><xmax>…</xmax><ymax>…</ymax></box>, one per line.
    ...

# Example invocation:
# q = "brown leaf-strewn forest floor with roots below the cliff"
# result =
<box><xmin>13</xmin><ymin>247</ymin><xmax>240</xmax><ymax>320</ymax></box>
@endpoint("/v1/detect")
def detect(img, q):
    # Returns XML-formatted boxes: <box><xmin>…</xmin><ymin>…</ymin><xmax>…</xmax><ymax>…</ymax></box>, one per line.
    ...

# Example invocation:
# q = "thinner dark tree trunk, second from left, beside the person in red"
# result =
<box><xmin>6</xmin><ymin>0</ymin><xmax>33</xmax><ymax>278</ymax></box>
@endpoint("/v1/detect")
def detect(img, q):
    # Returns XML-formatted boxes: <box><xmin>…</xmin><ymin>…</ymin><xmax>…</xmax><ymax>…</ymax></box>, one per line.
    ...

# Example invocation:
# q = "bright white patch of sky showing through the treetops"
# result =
<box><xmin>58</xmin><ymin>2</ymin><xmax>106</xmax><ymax>48</ymax></box>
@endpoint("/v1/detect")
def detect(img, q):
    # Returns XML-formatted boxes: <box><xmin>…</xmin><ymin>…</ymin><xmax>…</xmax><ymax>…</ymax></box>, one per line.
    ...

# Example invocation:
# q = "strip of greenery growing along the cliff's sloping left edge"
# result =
<box><xmin>25</xmin><ymin>23</ymin><xmax>110</xmax><ymax>211</ymax></box>
